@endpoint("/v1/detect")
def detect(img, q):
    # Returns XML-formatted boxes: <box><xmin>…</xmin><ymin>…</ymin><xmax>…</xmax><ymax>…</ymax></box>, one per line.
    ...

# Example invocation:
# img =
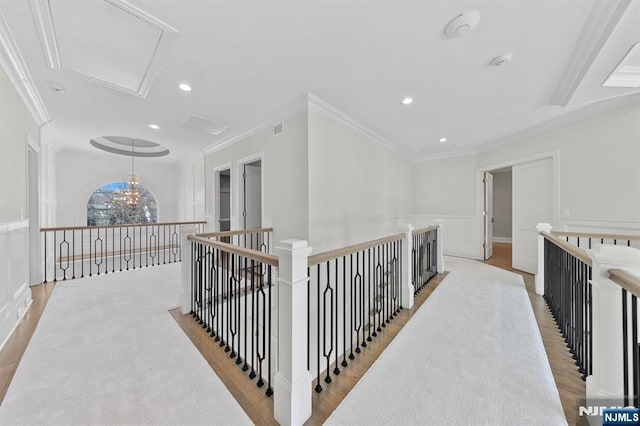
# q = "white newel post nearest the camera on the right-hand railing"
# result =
<box><xmin>586</xmin><ymin>245</ymin><xmax>640</xmax><ymax>402</ymax></box>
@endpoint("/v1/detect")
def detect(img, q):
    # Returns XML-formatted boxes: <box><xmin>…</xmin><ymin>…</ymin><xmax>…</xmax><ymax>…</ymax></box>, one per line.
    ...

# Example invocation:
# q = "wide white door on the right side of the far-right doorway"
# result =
<box><xmin>512</xmin><ymin>158</ymin><xmax>554</xmax><ymax>274</ymax></box>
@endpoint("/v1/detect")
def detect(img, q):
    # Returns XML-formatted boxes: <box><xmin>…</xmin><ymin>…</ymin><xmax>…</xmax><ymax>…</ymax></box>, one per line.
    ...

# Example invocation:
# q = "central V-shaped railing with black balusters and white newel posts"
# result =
<box><xmin>181</xmin><ymin>221</ymin><xmax>442</xmax><ymax>424</ymax></box>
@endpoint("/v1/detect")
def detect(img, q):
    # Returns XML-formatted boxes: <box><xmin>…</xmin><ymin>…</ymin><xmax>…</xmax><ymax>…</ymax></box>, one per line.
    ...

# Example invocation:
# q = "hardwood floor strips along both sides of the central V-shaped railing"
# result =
<box><xmin>171</xmin><ymin>273</ymin><xmax>446</xmax><ymax>425</ymax></box>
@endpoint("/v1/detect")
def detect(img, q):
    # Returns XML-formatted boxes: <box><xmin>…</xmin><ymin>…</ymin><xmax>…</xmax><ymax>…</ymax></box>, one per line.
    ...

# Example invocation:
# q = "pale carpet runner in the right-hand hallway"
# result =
<box><xmin>326</xmin><ymin>258</ymin><xmax>566</xmax><ymax>425</ymax></box>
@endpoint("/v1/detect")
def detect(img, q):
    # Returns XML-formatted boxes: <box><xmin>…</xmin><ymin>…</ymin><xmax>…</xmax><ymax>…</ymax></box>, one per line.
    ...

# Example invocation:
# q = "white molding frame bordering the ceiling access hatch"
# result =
<box><xmin>30</xmin><ymin>0</ymin><xmax>179</xmax><ymax>98</ymax></box>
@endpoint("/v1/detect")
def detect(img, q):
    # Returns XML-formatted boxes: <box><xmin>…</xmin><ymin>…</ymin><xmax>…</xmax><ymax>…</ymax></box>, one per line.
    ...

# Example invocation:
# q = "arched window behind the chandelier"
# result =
<box><xmin>87</xmin><ymin>182</ymin><xmax>158</xmax><ymax>226</ymax></box>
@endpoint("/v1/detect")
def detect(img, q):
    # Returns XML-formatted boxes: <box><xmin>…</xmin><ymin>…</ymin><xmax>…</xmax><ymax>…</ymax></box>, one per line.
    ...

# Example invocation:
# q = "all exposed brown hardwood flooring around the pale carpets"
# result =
<box><xmin>0</xmin><ymin>243</ymin><xmax>585</xmax><ymax>425</ymax></box>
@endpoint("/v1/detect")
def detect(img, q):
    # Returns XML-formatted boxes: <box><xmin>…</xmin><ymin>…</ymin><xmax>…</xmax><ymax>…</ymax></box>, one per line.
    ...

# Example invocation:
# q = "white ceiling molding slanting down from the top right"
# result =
<box><xmin>550</xmin><ymin>0</ymin><xmax>631</xmax><ymax>107</ymax></box>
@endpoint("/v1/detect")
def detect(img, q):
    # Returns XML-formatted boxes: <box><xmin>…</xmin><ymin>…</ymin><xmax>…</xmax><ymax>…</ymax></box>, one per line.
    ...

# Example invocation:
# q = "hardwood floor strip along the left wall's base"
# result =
<box><xmin>0</xmin><ymin>282</ymin><xmax>55</xmax><ymax>404</ymax></box>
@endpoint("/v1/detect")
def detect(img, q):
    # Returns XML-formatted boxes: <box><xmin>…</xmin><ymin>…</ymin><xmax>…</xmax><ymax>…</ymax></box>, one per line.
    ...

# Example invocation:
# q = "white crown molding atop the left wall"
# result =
<box><xmin>0</xmin><ymin>12</ymin><xmax>51</xmax><ymax>126</ymax></box>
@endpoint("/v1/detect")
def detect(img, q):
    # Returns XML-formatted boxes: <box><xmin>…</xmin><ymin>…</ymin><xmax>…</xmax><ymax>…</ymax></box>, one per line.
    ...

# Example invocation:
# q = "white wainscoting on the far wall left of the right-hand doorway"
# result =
<box><xmin>409</xmin><ymin>214</ymin><xmax>478</xmax><ymax>259</ymax></box>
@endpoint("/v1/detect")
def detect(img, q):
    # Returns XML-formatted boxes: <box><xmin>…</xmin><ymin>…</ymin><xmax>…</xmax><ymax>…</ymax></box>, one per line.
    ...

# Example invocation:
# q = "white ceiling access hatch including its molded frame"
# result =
<box><xmin>32</xmin><ymin>0</ymin><xmax>178</xmax><ymax>98</ymax></box>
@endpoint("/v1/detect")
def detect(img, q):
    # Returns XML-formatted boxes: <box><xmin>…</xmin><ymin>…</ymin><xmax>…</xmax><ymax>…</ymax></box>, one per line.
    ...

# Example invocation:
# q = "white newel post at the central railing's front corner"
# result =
<box><xmin>273</xmin><ymin>240</ymin><xmax>312</xmax><ymax>425</ymax></box>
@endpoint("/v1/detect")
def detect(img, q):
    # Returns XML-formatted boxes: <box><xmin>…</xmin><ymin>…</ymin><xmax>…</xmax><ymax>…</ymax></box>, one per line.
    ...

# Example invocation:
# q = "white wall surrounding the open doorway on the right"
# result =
<box><xmin>413</xmin><ymin>103</ymin><xmax>640</xmax><ymax>258</ymax></box>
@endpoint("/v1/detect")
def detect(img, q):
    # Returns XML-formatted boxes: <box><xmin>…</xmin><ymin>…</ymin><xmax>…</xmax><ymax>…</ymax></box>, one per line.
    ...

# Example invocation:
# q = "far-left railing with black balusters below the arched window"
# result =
<box><xmin>40</xmin><ymin>221</ymin><xmax>206</xmax><ymax>282</ymax></box>
